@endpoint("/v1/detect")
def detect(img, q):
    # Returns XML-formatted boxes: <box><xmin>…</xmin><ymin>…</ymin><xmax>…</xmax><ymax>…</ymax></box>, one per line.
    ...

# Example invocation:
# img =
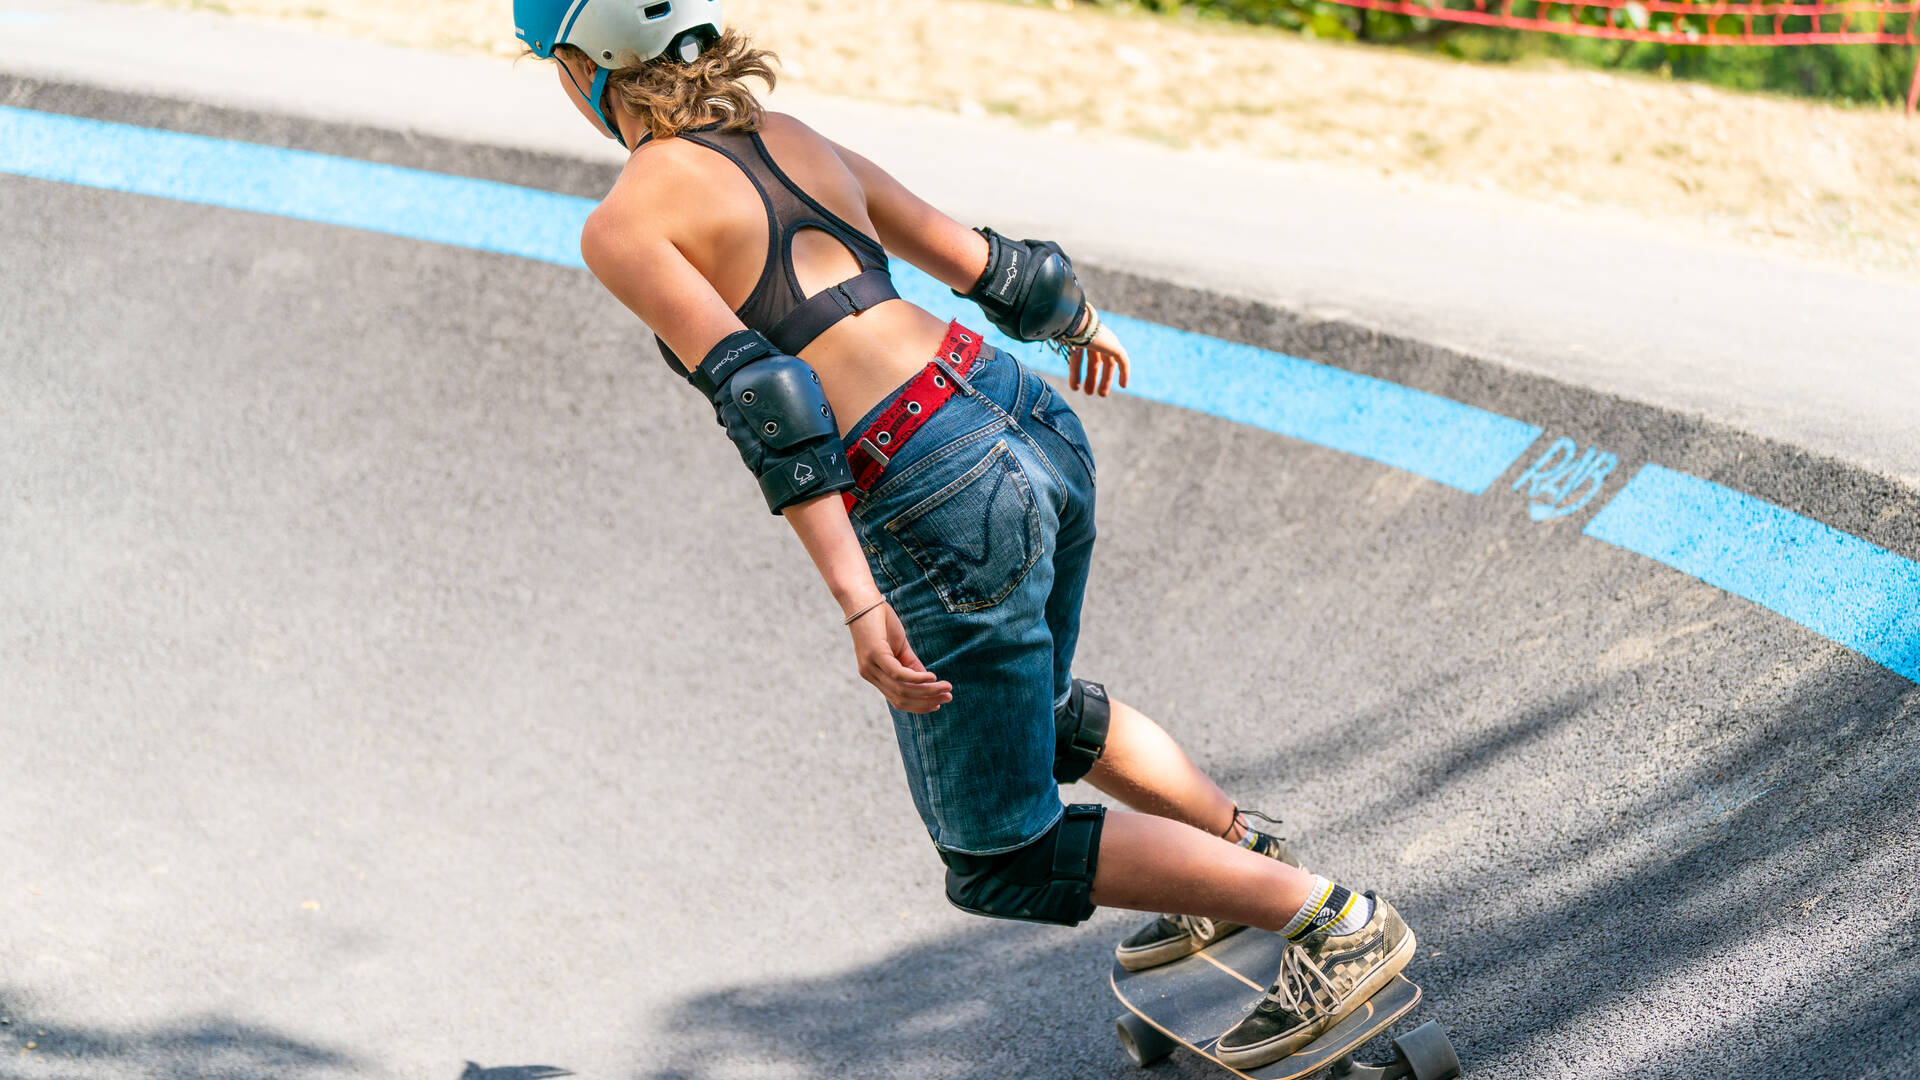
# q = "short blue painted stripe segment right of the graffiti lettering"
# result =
<box><xmin>1586</xmin><ymin>465</ymin><xmax>1920</xmax><ymax>682</ymax></box>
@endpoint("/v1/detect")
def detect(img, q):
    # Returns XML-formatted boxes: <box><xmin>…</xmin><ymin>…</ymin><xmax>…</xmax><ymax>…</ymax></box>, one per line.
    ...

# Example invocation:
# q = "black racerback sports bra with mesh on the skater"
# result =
<box><xmin>641</xmin><ymin>129</ymin><xmax>899</xmax><ymax>377</ymax></box>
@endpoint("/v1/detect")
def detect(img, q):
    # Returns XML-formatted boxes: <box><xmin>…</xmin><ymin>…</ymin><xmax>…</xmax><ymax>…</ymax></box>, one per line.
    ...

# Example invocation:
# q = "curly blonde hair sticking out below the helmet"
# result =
<box><xmin>553</xmin><ymin>27</ymin><xmax>780</xmax><ymax>138</ymax></box>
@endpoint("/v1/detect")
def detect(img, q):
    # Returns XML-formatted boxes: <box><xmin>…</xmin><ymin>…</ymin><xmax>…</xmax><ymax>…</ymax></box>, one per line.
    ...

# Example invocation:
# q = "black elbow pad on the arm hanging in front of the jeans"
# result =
<box><xmin>687</xmin><ymin>331</ymin><xmax>852</xmax><ymax>513</ymax></box>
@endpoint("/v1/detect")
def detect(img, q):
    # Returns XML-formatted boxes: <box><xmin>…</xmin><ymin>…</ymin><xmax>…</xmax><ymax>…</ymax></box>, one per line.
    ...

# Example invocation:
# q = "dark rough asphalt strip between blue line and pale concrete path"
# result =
<box><xmin>0</xmin><ymin>75</ymin><xmax>1920</xmax><ymax>555</ymax></box>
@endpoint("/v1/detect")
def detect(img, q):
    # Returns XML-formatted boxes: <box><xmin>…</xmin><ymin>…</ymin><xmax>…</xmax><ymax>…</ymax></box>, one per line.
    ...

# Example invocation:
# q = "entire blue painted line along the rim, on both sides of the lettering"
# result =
<box><xmin>15</xmin><ymin>106</ymin><xmax>1920</xmax><ymax>680</ymax></box>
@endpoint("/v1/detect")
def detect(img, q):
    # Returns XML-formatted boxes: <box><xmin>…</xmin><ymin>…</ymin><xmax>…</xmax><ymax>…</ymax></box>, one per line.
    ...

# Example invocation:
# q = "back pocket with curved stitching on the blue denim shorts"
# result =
<box><xmin>887</xmin><ymin>432</ymin><xmax>1044</xmax><ymax>613</ymax></box>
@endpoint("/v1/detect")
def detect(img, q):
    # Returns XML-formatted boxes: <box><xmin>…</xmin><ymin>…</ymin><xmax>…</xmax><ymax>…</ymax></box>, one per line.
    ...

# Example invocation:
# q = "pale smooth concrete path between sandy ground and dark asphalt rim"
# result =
<box><xmin>15</xmin><ymin>0</ymin><xmax>1920</xmax><ymax>484</ymax></box>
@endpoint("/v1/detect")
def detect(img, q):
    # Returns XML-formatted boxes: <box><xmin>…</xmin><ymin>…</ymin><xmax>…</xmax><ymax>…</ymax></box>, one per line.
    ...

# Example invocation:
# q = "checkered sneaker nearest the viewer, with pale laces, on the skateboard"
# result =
<box><xmin>1213</xmin><ymin>892</ymin><xmax>1413</xmax><ymax>1068</ymax></box>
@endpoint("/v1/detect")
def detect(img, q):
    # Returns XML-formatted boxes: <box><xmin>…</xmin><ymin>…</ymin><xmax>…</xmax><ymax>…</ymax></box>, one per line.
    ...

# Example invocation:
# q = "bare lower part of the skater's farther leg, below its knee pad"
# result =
<box><xmin>1087</xmin><ymin>701</ymin><xmax>1251</xmax><ymax>841</ymax></box>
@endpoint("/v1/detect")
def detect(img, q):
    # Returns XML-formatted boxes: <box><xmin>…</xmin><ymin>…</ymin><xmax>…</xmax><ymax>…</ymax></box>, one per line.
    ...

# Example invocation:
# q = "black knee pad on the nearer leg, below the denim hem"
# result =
<box><xmin>941</xmin><ymin>803</ymin><xmax>1106</xmax><ymax>926</ymax></box>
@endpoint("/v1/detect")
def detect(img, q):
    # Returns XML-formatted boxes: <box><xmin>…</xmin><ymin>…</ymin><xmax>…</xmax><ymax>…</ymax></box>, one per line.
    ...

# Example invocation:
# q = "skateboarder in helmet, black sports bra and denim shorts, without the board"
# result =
<box><xmin>515</xmin><ymin>0</ymin><xmax>1413</xmax><ymax>1067</ymax></box>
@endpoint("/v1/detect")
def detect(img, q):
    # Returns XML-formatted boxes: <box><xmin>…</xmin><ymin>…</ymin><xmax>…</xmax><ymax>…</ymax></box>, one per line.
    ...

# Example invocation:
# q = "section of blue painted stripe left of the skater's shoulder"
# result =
<box><xmin>0</xmin><ymin>106</ymin><xmax>593</xmax><ymax>267</ymax></box>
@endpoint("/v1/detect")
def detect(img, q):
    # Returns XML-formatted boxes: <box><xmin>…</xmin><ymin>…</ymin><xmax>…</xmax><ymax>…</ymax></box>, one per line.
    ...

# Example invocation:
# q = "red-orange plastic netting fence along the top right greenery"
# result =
<box><xmin>1334</xmin><ymin>0</ymin><xmax>1920</xmax><ymax>113</ymax></box>
